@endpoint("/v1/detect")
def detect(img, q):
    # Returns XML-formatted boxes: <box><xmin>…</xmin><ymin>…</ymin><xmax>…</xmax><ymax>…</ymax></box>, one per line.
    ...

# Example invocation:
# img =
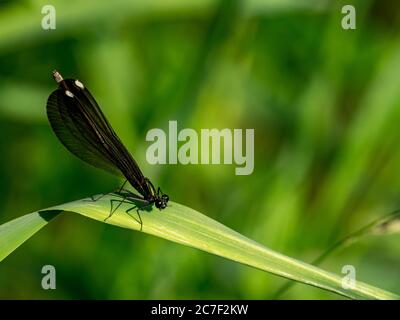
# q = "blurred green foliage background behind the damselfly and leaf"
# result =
<box><xmin>0</xmin><ymin>0</ymin><xmax>400</xmax><ymax>299</ymax></box>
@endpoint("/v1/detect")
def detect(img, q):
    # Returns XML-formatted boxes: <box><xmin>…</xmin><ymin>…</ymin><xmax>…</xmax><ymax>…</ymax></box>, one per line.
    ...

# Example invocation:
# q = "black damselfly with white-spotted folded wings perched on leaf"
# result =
<box><xmin>47</xmin><ymin>71</ymin><xmax>169</xmax><ymax>225</ymax></box>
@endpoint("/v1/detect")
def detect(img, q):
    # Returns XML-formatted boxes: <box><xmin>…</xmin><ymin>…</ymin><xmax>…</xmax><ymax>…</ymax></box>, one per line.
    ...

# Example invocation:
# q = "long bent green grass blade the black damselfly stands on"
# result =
<box><xmin>0</xmin><ymin>195</ymin><xmax>400</xmax><ymax>299</ymax></box>
